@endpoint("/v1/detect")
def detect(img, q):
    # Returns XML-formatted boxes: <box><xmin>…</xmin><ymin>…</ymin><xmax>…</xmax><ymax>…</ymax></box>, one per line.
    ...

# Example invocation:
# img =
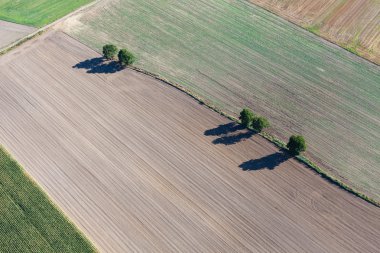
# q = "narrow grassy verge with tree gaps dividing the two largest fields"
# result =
<box><xmin>130</xmin><ymin>67</ymin><xmax>380</xmax><ymax>207</ymax></box>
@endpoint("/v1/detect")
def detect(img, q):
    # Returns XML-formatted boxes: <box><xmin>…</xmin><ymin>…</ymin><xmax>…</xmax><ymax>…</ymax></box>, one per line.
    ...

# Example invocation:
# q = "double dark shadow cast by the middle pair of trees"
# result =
<box><xmin>204</xmin><ymin>122</ymin><xmax>255</xmax><ymax>145</ymax></box>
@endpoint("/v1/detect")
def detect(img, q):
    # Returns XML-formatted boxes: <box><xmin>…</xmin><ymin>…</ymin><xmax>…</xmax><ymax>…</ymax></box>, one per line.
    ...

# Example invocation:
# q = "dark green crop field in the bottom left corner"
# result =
<box><xmin>0</xmin><ymin>148</ymin><xmax>95</xmax><ymax>253</ymax></box>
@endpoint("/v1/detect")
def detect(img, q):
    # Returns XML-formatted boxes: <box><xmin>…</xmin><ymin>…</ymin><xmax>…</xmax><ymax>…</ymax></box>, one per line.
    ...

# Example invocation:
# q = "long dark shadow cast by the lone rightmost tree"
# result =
<box><xmin>239</xmin><ymin>151</ymin><xmax>291</xmax><ymax>171</ymax></box>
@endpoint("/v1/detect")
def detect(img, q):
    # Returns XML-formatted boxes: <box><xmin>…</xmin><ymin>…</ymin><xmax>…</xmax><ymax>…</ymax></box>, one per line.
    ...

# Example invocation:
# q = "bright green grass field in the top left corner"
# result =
<box><xmin>0</xmin><ymin>0</ymin><xmax>92</xmax><ymax>27</ymax></box>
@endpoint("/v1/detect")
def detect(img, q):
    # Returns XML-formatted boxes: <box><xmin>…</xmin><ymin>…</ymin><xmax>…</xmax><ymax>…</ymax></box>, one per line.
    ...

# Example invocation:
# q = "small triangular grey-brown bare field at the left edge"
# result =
<box><xmin>0</xmin><ymin>20</ymin><xmax>36</xmax><ymax>49</ymax></box>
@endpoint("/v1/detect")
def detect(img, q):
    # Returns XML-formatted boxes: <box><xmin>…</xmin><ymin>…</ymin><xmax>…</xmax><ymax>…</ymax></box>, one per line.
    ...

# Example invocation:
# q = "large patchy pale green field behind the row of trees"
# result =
<box><xmin>65</xmin><ymin>0</ymin><xmax>380</xmax><ymax>201</ymax></box>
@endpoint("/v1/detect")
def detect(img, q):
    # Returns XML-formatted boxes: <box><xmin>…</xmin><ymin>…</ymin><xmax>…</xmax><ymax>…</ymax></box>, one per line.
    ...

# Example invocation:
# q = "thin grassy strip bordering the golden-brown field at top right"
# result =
<box><xmin>246</xmin><ymin>0</ymin><xmax>380</xmax><ymax>66</ymax></box>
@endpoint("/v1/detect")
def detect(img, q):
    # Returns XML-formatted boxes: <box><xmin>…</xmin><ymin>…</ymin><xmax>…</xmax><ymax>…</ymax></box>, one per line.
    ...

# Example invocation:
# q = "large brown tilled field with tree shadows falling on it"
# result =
<box><xmin>0</xmin><ymin>33</ymin><xmax>380</xmax><ymax>252</ymax></box>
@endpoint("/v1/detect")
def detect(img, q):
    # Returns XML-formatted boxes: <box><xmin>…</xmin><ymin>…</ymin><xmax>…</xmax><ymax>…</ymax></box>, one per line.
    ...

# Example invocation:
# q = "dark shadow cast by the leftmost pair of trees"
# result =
<box><xmin>73</xmin><ymin>57</ymin><xmax>123</xmax><ymax>74</ymax></box>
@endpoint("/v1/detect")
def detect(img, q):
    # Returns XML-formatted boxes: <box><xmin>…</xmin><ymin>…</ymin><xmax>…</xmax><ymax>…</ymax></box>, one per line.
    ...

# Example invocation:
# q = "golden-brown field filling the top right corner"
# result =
<box><xmin>249</xmin><ymin>0</ymin><xmax>380</xmax><ymax>64</ymax></box>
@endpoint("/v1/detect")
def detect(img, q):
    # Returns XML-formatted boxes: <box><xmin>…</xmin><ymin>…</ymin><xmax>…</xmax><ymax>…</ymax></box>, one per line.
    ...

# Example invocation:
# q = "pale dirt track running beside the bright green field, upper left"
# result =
<box><xmin>0</xmin><ymin>0</ymin><xmax>102</xmax><ymax>56</ymax></box>
